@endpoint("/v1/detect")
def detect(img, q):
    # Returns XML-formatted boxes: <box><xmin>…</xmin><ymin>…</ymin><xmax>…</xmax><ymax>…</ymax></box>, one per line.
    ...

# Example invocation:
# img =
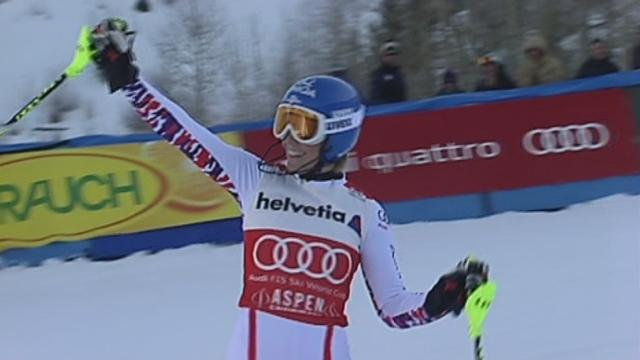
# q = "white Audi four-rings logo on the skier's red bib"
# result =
<box><xmin>253</xmin><ymin>234</ymin><xmax>353</xmax><ymax>285</ymax></box>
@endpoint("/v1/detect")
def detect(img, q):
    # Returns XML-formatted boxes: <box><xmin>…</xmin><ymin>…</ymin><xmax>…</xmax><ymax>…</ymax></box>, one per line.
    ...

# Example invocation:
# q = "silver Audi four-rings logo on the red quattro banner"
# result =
<box><xmin>522</xmin><ymin>123</ymin><xmax>611</xmax><ymax>156</ymax></box>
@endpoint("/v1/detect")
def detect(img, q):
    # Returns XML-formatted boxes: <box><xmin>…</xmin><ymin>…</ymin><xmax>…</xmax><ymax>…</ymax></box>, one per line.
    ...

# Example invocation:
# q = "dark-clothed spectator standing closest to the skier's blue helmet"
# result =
<box><xmin>369</xmin><ymin>40</ymin><xmax>407</xmax><ymax>105</ymax></box>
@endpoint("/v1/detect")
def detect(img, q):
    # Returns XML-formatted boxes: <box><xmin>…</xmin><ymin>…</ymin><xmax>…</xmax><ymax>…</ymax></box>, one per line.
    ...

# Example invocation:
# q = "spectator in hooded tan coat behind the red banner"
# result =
<box><xmin>518</xmin><ymin>34</ymin><xmax>566</xmax><ymax>86</ymax></box>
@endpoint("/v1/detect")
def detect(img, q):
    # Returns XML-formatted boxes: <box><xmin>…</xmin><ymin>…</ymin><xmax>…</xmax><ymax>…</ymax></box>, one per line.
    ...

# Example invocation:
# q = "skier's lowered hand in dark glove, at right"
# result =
<box><xmin>424</xmin><ymin>257</ymin><xmax>489</xmax><ymax>317</ymax></box>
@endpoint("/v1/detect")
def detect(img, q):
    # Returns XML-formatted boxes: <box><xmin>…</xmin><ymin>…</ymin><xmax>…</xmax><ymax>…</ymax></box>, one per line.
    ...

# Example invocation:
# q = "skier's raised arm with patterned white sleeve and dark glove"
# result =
<box><xmin>85</xmin><ymin>18</ymin><xmax>261</xmax><ymax>210</ymax></box>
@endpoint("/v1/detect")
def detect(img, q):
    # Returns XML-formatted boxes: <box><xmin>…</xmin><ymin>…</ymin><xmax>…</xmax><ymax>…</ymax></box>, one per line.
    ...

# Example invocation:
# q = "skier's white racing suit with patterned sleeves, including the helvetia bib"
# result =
<box><xmin>124</xmin><ymin>80</ymin><xmax>436</xmax><ymax>360</ymax></box>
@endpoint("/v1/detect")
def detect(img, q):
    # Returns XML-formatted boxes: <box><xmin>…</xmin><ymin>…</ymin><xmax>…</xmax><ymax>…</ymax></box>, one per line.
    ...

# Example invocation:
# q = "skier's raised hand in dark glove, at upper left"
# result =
<box><xmin>91</xmin><ymin>18</ymin><xmax>138</xmax><ymax>93</ymax></box>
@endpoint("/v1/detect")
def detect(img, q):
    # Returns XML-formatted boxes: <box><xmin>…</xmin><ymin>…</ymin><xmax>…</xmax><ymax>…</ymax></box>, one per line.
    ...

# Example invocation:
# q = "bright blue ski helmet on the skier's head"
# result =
<box><xmin>280</xmin><ymin>75</ymin><xmax>365</xmax><ymax>163</ymax></box>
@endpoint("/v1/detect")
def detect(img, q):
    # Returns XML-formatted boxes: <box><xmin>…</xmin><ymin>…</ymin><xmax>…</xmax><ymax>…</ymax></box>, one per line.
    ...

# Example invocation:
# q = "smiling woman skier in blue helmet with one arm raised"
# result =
<box><xmin>92</xmin><ymin>19</ymin><xmax>488</xmax><ymax>360</ymax></box>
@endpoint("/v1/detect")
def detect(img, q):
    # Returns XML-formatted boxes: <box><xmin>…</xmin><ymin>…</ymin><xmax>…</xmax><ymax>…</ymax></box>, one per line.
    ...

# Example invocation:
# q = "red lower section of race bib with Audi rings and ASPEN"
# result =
<box><xmin>240</xmin><ymin>229</ymin><xmax>360</xmax><ymax>326</ymax></box>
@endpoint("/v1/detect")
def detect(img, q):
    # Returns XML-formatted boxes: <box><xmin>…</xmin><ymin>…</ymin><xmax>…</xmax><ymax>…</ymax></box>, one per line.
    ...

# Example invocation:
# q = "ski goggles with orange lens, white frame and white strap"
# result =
<box><xmin>273</xmin><ymin>104</ymin><xmax>365</xmax><ymax>145</ymax></box>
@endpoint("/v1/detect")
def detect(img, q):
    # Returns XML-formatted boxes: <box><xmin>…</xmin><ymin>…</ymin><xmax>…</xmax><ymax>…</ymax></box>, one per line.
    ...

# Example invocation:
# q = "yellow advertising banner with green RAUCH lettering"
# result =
<box><xmin>0</xmin><ymin>133</ymin><xmax>241</xmax><ymax>251</ymax></box>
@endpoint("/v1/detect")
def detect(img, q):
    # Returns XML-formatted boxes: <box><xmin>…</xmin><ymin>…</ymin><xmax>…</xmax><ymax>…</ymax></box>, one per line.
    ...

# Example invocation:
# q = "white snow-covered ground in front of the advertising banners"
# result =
<box><xmin>0</xmin><ymin>196</ymin><xmax>640</xmax><ymax>360</ymax></box>
